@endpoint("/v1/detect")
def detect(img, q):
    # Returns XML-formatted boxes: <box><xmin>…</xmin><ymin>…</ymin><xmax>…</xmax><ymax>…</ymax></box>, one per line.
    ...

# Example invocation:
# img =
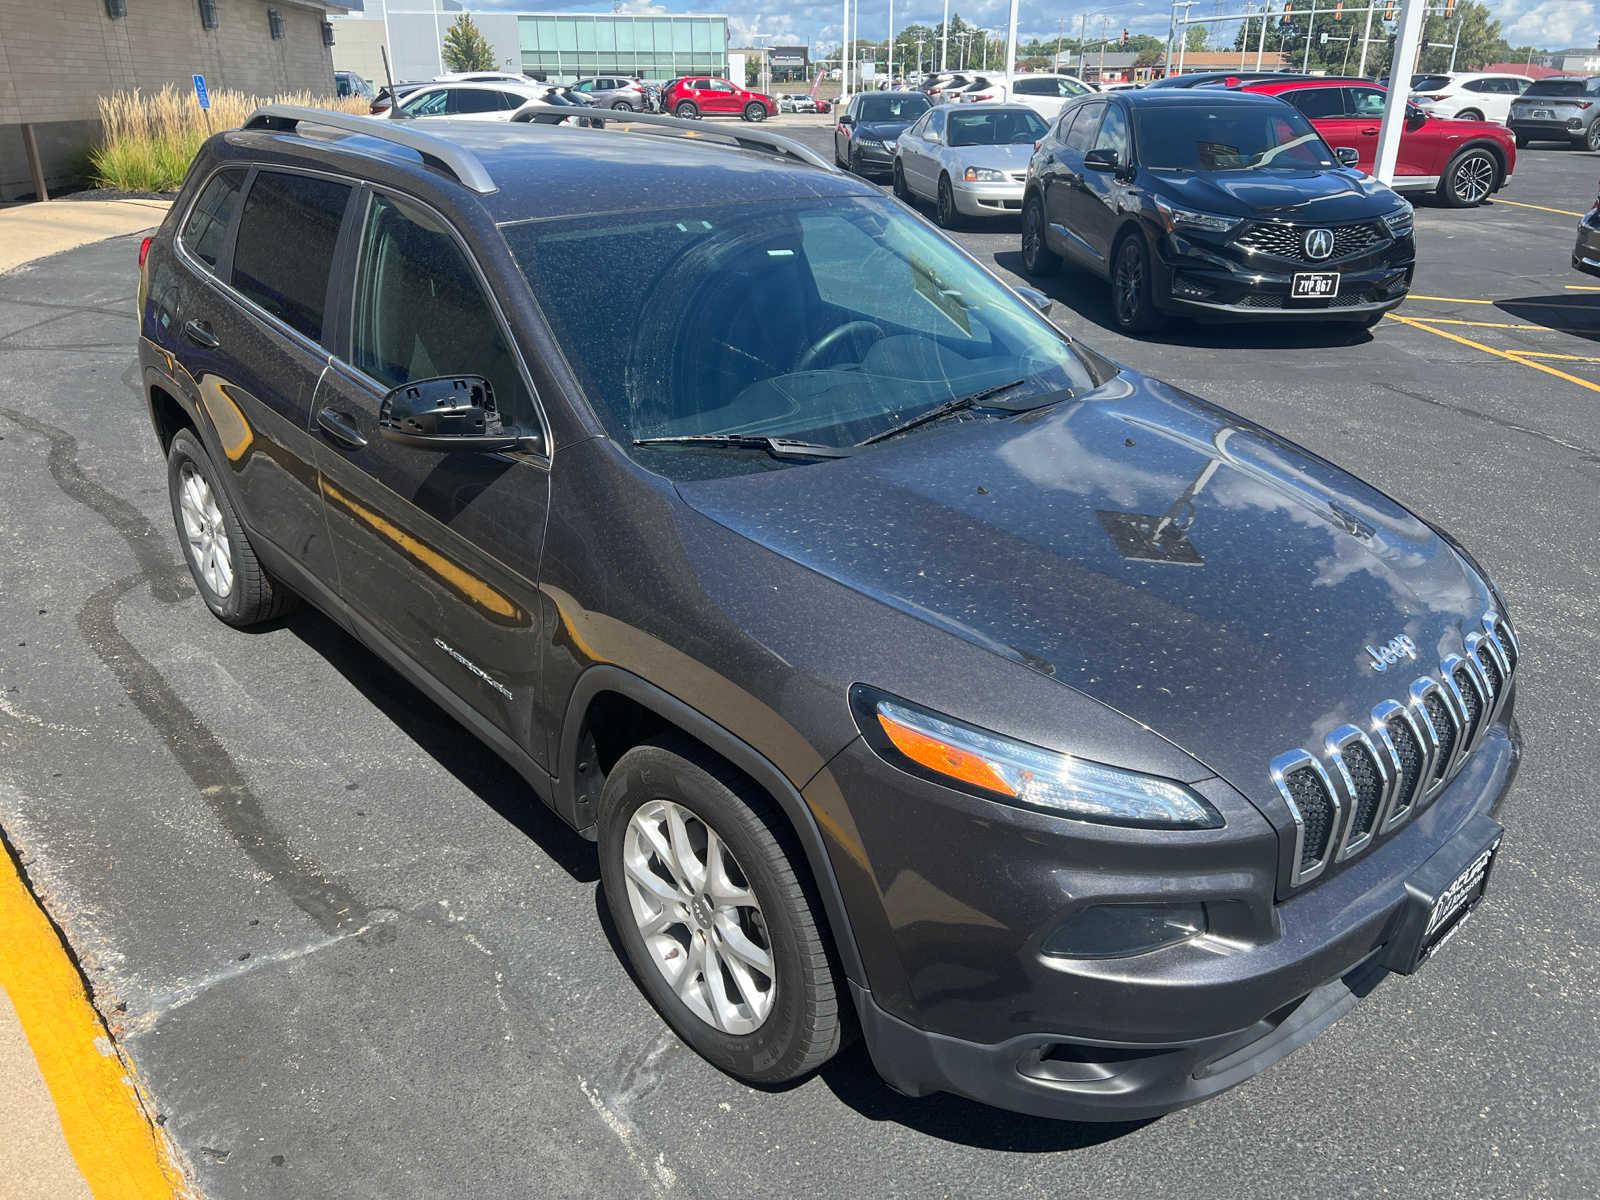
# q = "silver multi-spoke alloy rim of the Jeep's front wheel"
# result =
<box><xmin>622</xmin><ymin>800</ymin><xmax>778</xmax><ymax>1034</ymax></box>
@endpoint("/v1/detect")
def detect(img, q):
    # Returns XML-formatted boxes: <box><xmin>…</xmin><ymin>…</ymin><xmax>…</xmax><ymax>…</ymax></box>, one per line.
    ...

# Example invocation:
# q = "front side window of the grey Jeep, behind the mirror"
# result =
<box><xmin>350</xmin><ymin>195</ymin><xmax>531</xmax><ymax>427</ymax></box>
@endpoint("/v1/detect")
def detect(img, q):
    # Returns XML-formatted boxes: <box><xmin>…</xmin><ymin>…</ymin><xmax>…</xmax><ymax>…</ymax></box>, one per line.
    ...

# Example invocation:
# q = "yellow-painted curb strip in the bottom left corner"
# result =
<box><xmin>0</xmin><ymin>850</ymin><xmax>181</xmax><ymax>1200</ymax></box>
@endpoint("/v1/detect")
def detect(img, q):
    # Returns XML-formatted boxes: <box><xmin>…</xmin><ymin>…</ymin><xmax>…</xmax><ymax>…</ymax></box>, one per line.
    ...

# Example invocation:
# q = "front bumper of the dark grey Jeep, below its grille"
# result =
<box><xmin>835</xmin><ymin>723</ymin><xmax>1520</xmax><ymax>1120</ymax></box>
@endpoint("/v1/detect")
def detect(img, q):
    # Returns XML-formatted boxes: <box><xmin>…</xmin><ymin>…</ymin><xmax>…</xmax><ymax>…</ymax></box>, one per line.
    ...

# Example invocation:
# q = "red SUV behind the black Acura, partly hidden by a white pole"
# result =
<box><xmin>1240</xmin><ymin>78</ymin><xmax>1517</xmax><ymax>208</ymax></box>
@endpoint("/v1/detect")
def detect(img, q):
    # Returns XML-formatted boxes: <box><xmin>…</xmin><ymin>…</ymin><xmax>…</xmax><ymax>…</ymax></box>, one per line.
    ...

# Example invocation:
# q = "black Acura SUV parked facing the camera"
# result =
<box><xmin>1022</xmin><ymin>88</ymin><xmax>1416</xmax><ymax>333</ymax></box>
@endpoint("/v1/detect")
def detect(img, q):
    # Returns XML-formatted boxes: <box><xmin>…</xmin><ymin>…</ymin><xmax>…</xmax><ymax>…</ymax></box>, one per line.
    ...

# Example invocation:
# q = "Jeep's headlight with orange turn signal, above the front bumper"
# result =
<box><xmin>850</xmin><ymin>685</ymin><xmax>1222</xmax><ymax>829</ymax></box>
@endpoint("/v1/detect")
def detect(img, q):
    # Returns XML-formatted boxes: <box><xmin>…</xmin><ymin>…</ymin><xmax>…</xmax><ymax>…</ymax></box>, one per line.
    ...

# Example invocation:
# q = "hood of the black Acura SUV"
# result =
<box><xmin>1150</xmin><ymin>168</ymin><xmax>1398</xmax><ymax>221</ymax></box>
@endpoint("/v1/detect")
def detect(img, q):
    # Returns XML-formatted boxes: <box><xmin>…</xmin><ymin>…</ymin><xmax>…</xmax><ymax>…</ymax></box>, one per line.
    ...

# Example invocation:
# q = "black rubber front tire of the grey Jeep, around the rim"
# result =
<box><xmin>597</xmin><ymin>734</ymin><xmax>843</xmax><ymax>1085</ymax></box>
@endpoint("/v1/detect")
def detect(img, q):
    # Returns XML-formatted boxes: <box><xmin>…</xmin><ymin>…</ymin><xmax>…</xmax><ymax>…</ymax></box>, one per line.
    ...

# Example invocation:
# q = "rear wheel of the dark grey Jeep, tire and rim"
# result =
<box><xmin>166</xmin><ymin>429</ymin><xmax>294</xmax><ymax>629</ymax></box>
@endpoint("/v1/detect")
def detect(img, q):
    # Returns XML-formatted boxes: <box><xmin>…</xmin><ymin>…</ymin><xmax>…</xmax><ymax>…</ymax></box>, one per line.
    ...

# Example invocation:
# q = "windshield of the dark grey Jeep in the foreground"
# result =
<box><xmin>501</xmin><ymin>197</ymin><xmax>1106</xmax><ymax>472</ymax></box>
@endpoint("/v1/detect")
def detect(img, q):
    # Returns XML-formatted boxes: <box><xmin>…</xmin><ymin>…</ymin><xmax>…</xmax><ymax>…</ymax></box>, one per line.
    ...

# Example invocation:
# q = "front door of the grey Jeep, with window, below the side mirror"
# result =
<box><xmin>317</xmin><ymin>194</ymin><xmax>549</xmax><ymax>762</ymax></box>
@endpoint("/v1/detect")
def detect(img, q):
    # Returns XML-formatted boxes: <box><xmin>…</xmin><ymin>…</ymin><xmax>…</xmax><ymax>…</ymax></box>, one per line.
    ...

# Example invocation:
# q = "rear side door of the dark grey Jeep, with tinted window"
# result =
<box><xmin>173</xmin><ymin>168</ymin><xmax>354</xmax><ymax>584</ymax></box>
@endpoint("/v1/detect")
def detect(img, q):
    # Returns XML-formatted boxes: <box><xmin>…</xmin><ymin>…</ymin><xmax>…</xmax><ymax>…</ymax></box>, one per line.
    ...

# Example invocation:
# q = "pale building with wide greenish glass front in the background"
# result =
<box><xmin>334</xmin><ymin>0</ymin><xmax>728</xmax><ymax>80</ymax></box>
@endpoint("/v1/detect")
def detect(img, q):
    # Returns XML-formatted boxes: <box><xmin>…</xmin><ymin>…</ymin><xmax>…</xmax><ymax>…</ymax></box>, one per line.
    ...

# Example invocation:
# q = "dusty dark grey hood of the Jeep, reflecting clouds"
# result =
<box><xmin>678</xmin><ymin>373</ymin><xmax>1494</xmax><ymax>802</ymax></box>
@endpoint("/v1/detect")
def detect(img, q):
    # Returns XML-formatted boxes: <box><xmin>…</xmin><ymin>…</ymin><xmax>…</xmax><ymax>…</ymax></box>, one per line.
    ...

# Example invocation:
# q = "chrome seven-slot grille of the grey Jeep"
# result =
<box><xmin>1270</xmin><ymin>613</ymin><xmax>1517</xmax><ymax>886</ymax></box>
